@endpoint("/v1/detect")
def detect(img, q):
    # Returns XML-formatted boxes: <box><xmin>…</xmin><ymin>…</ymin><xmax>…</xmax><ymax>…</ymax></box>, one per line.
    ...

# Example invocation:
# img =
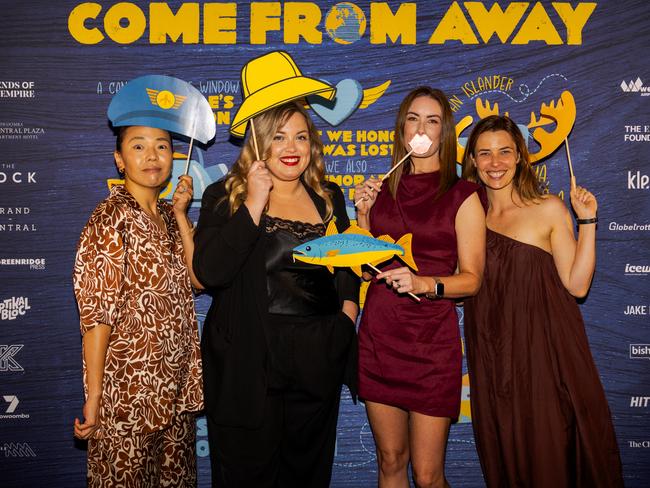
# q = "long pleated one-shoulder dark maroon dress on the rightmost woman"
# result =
<box><xmin>465</xmin><ymin>229</ymin><xmax>623</xmax><ymax>488</ymax></box>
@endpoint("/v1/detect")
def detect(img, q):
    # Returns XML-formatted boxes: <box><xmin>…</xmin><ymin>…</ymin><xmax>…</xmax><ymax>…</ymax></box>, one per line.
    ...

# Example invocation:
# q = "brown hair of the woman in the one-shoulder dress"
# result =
<box><xmin>463</xmin><ymin>115</ymin><xmax>542</xmax><ymax>202</ymax></box>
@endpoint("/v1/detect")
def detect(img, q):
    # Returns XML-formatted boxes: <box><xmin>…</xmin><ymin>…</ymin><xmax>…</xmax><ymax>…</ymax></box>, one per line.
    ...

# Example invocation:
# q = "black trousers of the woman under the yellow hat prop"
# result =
<box><xmin>208</xmin><ymin>313</ymin><xmax>354</xmax><ymax>488</ymax></box>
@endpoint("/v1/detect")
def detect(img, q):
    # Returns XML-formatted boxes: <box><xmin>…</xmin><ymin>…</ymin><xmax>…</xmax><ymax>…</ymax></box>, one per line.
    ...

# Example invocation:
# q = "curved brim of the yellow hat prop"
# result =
<box><xmin>230</xmin><ymin>76</ymin><xmax>336</xmax><ymax>137</ymax></box>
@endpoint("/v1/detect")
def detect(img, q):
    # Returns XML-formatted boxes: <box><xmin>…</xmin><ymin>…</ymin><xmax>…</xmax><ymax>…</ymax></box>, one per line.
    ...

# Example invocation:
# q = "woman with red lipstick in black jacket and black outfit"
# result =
<box><xmin>194</xmin><ymin>102</ymin><xmax>358</xmax><ymax>488</ymax></box>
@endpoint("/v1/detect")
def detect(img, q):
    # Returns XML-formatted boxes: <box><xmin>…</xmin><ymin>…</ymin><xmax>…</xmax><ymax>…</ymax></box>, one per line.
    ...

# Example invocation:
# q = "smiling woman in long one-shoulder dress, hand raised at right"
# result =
<box><xmin>463</xmin><ymin>116</ymin><xmax>623</xmax><ymax>488</ymax></box>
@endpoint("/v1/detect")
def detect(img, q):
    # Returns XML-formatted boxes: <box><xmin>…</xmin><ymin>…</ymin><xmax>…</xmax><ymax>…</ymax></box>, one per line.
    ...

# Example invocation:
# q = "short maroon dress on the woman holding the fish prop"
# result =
<box><xmin>359</xmin><ymin>172</ymin><xmax>479</xmax><ymax>418</ymax></box>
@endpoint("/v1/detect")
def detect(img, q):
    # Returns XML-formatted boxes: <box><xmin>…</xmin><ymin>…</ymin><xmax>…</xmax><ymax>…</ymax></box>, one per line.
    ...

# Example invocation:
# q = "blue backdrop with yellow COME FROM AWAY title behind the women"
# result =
<box><xmin>0</xmin><ymin>0</ymin><xmax>650</xmax><ymax>487</ymax></box>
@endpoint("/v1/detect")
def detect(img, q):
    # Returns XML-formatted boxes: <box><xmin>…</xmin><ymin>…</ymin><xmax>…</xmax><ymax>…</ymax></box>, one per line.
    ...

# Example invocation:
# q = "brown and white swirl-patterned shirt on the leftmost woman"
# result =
<box><xmin>74</xmin><ymin>186</ymin><xmax>203</xmax><ymax>484</ymax></box>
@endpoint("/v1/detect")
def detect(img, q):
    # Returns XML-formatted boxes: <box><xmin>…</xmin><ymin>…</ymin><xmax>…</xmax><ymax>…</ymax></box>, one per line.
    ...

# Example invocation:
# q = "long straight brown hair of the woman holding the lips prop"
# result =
<box><xmin>388</xmin><ymin>86</ymin><xmax>458</xmax><ymax>198</ymax></box>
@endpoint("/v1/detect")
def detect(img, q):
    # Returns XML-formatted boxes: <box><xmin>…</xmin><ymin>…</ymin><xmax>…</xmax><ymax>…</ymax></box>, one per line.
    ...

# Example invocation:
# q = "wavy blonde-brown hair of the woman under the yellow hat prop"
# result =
<box><xmin>226</xmin><ymin>102</ymin><xmax>333</xmax><ymax>220</ymax></box>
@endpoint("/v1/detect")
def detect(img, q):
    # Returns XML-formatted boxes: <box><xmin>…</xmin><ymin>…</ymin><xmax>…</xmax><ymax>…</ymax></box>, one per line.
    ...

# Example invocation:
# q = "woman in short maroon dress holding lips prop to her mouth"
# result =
<box><xmin>355</xmin><ymin>87</ymin><xmax>485</xmax><ymax>487</ymax></box>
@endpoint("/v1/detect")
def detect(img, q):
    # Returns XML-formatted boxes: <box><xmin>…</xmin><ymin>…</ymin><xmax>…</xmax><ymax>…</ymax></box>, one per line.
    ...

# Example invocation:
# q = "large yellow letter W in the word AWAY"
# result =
<box><xmin>465</xmin><ymin>2</ymin><xmax>529</xmax><ymax>44</ymax></box>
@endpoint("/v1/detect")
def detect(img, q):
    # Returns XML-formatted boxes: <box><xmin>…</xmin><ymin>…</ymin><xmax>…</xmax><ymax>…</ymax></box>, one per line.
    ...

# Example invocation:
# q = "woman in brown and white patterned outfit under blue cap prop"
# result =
<box><xmin>74</xmin><ymin>127</ymin><xmax>203</xmax><ymax>487</ymax></box>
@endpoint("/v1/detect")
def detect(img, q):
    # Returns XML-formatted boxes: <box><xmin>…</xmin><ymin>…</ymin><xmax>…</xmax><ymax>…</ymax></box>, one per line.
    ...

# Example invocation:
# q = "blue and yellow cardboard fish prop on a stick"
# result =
<box><xmin>293</xmin><ymin>221</ymin><xmax>418</xmax><ymax>276</ymax></box>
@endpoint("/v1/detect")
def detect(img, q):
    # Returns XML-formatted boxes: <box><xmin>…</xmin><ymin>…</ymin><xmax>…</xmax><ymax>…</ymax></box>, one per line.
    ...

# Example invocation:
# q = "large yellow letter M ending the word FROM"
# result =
<box><xmin>370</xmin><ymin>3</ymin><xmax>417</xmax><ymax>44</ymax></box>
